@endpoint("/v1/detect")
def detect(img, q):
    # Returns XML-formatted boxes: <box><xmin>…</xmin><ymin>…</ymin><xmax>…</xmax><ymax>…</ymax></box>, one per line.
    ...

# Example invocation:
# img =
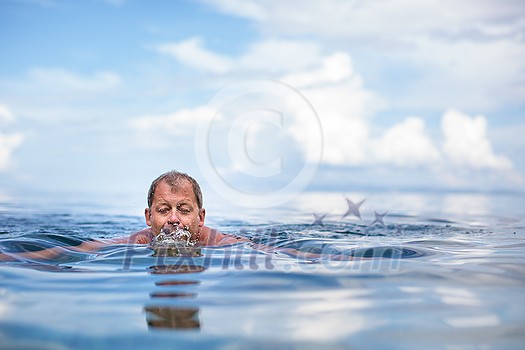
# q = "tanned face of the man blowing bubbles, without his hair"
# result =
<box><xmin>145</xmin><ymin>181</ymin><xmax>205</xmax><ymax>239</ymax></box>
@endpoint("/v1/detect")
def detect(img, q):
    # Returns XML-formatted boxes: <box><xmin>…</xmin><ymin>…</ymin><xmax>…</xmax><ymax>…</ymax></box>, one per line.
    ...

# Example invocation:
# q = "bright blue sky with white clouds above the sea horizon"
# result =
<box><xmin>0</xmin><ymin>0</ymin><xmax>525</xmax><ymax>205</ymax></box>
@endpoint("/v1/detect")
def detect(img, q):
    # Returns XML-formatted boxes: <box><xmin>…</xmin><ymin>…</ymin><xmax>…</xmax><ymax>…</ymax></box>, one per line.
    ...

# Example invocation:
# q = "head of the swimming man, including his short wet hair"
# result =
<box><xmin>145</xmin><ymin>171</ymin><xmax>205</xmax><ymax>239</ymax></box>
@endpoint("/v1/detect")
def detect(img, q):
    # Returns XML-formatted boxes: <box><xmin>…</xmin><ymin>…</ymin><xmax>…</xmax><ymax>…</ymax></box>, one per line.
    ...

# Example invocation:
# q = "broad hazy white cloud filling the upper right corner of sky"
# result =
<box><xmin>201</xmin><ymin>0</ymin><xmax>525</xmax><ymax>111</ymax></box>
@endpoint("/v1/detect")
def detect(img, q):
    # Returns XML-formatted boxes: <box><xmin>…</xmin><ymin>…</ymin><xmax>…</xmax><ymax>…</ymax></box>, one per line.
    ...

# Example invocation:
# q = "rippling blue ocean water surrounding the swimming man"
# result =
<box><xmin>0</xmin><ymin>193</ymin><xmax>525</xmax><ymax>349</ymax></box>
